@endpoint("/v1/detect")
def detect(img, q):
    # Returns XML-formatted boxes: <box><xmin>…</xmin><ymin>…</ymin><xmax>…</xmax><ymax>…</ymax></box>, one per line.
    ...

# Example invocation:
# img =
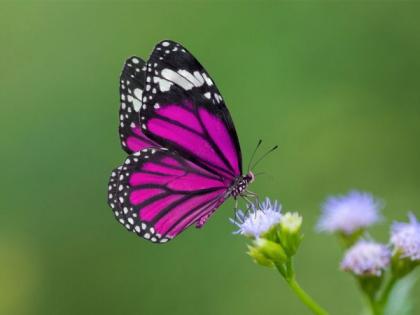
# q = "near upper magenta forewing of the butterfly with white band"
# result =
<box><xmin>140</xmin><ymin>40</ymin><xmax>242</xmax><ymax>182</ymax></box>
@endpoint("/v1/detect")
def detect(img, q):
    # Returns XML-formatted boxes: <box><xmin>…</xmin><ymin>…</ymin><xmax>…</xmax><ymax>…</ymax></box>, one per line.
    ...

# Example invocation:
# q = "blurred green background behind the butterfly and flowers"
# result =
<box><xmin>0</xmin><ymin>1</ymin><xmax>420</xmax><ymax>315</ymax></box>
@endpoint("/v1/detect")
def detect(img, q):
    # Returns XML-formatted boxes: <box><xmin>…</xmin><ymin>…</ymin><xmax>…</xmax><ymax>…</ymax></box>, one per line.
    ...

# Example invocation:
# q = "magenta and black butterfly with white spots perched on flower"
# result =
<box><xmin>108</xmin><ymin>40</ymin><xmax>255</xmax><ymax>243</ymax></box>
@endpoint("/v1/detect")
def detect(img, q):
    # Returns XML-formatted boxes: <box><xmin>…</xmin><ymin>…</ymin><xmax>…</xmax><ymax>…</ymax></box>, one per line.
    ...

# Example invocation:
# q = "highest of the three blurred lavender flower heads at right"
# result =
<box><xmin>318</xmin><ymin>191</ymin><xmax>382</xmax><ymax>235</ymax></box>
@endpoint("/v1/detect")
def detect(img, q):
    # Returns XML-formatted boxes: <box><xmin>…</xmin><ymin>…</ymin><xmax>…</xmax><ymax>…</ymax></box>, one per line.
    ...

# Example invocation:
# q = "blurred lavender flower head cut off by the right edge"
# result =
<box><xmin>391</xmin><ymin>213</ymin><xmax>420</xmax><ymax>261</ymax></box>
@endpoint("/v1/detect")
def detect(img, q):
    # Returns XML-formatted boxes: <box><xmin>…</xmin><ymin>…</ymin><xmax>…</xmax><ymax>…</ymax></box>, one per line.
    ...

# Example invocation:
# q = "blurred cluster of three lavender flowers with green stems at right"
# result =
<box><xmin>318</xmin><ymin>191</ymin><xmax>420</xmax><ymax>314</ymax></box>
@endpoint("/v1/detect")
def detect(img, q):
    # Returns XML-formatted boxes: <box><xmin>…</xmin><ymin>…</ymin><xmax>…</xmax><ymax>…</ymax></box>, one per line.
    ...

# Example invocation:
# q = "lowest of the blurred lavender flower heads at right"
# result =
<box><xmin>340</xmin><ymin>240</ymin><xmax>391</xmax><ymax>277</ymax></box>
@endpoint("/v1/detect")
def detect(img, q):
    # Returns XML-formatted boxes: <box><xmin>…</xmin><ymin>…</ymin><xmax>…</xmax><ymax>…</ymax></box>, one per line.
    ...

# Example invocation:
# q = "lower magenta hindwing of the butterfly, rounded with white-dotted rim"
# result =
<box><xmin>108</xmin><ymin>148</ymin><xmax>229</xmax><ymax>243</ymax></box>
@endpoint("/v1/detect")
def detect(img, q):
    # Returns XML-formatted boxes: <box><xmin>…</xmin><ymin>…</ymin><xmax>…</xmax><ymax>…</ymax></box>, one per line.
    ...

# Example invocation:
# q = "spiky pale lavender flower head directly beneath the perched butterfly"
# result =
<box><xmin>230</xmin><ymin>198</ymin><xmax>282</xmax><ymax>238</ymax></box>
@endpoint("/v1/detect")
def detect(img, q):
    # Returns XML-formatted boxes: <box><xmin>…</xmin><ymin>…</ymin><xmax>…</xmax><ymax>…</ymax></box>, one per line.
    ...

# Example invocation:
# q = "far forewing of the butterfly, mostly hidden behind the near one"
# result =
<box><xmin>119</xmin><ymin>57</ymin><xmax>156</xmax><ymax>154</ymax></box>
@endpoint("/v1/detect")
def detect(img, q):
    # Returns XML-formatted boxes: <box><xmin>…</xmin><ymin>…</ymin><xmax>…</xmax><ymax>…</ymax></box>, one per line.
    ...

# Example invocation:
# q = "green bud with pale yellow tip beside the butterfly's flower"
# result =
<box><xmin>278</xmin><ymin>212</ymin><xmax>303</xmax><ymax>256</ymax></box>
